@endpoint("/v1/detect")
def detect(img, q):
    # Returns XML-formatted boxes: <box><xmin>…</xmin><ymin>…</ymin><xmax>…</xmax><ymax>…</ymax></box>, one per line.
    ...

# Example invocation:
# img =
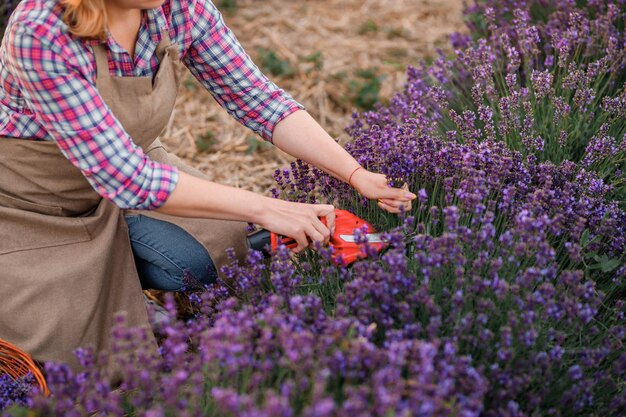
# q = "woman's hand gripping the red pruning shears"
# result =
<box><xmin>260</xmin><ymin>199</ymin><xmax>335</xmax><ymax>253</ymax></box>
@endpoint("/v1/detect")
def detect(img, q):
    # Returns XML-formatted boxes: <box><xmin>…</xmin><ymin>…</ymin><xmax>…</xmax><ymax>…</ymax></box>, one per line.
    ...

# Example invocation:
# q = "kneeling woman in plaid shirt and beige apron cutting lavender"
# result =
<box><xmin>0</xmin><ymin>0</ymin><xmax>415</xmax><ymax>364</ymax></box>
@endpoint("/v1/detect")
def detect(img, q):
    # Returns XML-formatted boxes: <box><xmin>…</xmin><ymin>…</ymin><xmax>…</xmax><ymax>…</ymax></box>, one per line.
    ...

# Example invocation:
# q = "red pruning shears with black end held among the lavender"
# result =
<box><xmin>248</xmin><ymin>210</ymin><xmax>388</xmax><ymax>266</ymax></box>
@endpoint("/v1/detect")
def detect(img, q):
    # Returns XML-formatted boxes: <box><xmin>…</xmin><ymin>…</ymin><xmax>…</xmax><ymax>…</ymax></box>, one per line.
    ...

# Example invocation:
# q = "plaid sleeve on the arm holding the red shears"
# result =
<box><xmin>6</xmin><ymin>22</ymin><xmax>178</xmax><ymax>209</ymax></box>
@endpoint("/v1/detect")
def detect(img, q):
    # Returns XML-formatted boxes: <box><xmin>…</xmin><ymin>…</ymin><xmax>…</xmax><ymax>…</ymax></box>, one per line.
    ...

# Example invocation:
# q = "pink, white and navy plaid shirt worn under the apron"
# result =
<box><xmin>0</xmin><ymin>0</ymin><xmax>302</xmax><ymax>209</ymax></box>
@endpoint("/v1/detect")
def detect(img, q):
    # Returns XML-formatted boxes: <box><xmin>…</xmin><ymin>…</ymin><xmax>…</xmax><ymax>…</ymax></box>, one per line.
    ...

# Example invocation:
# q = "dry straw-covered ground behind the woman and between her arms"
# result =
<box><xmin>162</xmin><ymin>0</ymin><xmax>463</xmax><ymax>194</ymax></box>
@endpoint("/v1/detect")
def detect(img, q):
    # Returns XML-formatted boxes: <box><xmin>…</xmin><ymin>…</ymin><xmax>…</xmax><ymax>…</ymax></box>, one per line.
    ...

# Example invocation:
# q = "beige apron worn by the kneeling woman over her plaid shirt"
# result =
<box><xmin>0</xmin><ymin>31</ymin><xmax>246</xmax><ymax>366</ymax></box>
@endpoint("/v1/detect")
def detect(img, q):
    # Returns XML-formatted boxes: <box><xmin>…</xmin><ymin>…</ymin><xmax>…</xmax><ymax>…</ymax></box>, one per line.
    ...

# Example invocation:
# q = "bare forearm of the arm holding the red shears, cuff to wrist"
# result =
<box><xmin>156</xmin><ymin>171</ymin><xmax>272</xmax><ymax>224</ymax></box>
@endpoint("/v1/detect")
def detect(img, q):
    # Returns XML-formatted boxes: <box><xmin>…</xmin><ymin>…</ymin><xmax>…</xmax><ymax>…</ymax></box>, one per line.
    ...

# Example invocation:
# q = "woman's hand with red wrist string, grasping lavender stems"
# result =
<box><xmin>350</xmin><ymin>168</ymin><xmax>417</xmax><ymax>214</ymax></box>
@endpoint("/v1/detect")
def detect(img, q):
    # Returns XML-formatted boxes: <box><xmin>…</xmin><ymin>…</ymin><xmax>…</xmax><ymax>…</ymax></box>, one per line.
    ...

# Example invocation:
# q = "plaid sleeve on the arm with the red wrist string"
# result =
<box><xmin>183</xmin><ymin>0</ymin><xmax>304</xmax><ymax>141</ymax></box>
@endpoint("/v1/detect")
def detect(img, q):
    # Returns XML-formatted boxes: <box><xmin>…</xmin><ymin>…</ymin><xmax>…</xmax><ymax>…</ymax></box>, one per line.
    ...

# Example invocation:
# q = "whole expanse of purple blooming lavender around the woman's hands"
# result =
<box><xmin>0</xmin><ymin>0</ymin><xmax>626</xmax><ymax>417</ymax></box>
